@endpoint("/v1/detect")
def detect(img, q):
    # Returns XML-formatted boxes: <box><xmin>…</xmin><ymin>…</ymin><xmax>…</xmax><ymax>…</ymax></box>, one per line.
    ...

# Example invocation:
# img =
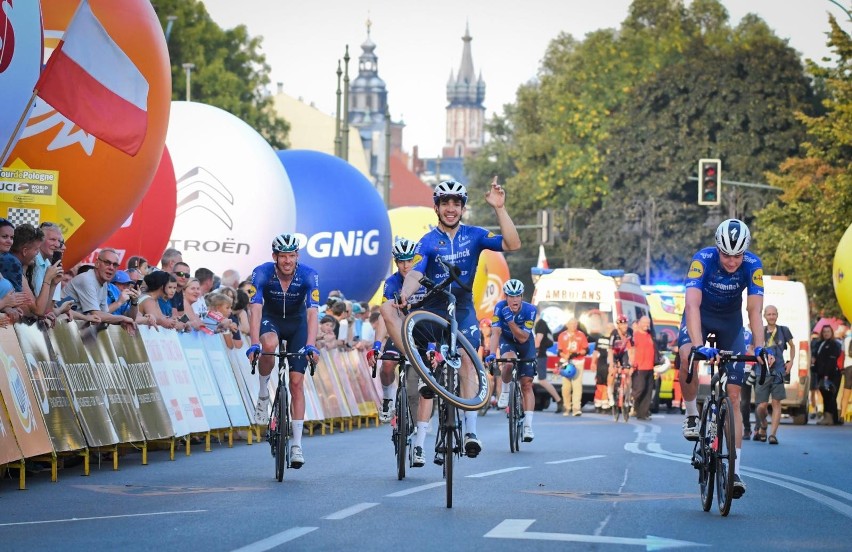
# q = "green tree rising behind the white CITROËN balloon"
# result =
<box><xmin>151</xmin><ymin>0</ymin><xmax>290</xmax><ymax>149</ymax></box>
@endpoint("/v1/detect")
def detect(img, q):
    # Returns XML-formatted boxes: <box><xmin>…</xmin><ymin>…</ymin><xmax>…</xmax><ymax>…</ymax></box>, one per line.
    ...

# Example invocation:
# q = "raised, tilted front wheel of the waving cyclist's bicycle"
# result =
<box><xmin>402</xmin><ymin>311</ymin><xmax>489</xmax><ymax>410</ymax></box>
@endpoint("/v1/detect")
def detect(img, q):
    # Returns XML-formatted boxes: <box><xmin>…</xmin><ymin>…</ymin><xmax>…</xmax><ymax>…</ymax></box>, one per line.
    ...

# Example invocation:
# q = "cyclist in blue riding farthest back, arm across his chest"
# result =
<box><xmin>485</xmin><ymin>278</ymin><xmax>538</xmax><ymax>443</ymax></box>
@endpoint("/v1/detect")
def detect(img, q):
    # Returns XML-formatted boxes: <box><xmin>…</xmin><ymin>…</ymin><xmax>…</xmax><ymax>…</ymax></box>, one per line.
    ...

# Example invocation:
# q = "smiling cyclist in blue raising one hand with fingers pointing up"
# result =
<box><xmin>382</xmin><ymin>176</ymin><xmax>521</xmax><ymax>458</ymax></box>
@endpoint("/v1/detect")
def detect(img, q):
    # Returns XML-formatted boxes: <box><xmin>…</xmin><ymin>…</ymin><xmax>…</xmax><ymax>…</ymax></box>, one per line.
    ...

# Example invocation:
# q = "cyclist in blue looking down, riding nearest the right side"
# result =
<box><xmin>678</xmin><ymin>219</ymin><xmax>772</xmax><ymax>498</ymax></box>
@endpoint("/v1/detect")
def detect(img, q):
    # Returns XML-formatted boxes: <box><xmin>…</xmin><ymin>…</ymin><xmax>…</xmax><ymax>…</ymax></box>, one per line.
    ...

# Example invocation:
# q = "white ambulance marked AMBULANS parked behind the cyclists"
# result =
<box><xmin>532</xmin><ymin>268</ymin><xmax>649</xmax><ymax>408</ymax></box>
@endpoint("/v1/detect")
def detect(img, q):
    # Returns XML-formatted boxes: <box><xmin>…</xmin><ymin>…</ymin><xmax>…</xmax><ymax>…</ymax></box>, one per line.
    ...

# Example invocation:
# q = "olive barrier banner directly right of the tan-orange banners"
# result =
<box><xmin>13</xmin><ymin>324</ymin><xmax>86</xmax><ymax>452</ymax></box>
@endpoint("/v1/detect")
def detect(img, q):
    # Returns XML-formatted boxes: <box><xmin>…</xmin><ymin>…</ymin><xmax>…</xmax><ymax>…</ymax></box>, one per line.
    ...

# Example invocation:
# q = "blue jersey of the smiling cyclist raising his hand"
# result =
<box><xmin>412</xmin><ymin>224</ymin><xmax>503</xmax><ymax>308</ymax></box>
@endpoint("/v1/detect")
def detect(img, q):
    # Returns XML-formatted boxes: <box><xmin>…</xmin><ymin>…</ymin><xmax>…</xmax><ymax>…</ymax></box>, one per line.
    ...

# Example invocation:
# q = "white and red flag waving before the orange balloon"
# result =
<box><xmin>35</xmin><ymin>0</ymin><xmax>148</xmax><ymax>155</ymax></box>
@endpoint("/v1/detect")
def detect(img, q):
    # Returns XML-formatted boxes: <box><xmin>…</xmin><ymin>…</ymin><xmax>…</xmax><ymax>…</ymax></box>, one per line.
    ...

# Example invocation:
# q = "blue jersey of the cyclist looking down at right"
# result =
<box><xmin>686</xmin><ymin>247</ymin><xmax>763</xmax><ymax>315</ymax></box>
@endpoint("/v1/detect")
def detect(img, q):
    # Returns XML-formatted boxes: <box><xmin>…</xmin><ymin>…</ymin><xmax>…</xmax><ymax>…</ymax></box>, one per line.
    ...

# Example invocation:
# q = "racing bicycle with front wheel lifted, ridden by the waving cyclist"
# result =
<box><xmin>402</xmin><ymin>257</ymin><xmax>491</xmax><ymax>508</ymax></box>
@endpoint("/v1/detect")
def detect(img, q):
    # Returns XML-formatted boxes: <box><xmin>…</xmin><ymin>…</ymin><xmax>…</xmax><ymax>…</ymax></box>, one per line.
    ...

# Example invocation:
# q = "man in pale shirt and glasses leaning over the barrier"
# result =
<box><xmin>67</xmin><ymin>248</ymin><xmax>138</xmax><ymax>332</ymax></box>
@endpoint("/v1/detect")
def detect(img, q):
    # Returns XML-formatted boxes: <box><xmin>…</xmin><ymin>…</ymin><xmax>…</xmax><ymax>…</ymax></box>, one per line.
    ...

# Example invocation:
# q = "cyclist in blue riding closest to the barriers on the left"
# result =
<box><xmin>246</xmin><ymin>234</ymin><xmax>319</xmax><ymax>469</ymax></box>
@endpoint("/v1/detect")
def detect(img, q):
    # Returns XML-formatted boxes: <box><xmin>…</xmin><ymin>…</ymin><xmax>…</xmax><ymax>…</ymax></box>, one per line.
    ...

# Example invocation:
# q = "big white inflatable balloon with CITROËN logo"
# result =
<box><xmin>166</xmin><ymin>102</ymin><xmax>296</xmax><ymax>279</ymax></box>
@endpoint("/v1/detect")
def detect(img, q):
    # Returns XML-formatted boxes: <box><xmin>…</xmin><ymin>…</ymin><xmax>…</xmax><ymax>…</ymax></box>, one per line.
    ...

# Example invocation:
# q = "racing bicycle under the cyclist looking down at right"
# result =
<box><xmin>686</xmin><ymin>347</ymin><xmax>769</xmax><ymax>516</ymax></box>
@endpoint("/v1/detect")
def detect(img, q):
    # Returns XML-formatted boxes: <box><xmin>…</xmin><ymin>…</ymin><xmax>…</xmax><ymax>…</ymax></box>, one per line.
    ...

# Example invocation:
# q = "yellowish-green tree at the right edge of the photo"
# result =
<box><xmin>754</xmin><ymin>17</ymin><xmax>852</xmax><ymax>316</ymax></box>
